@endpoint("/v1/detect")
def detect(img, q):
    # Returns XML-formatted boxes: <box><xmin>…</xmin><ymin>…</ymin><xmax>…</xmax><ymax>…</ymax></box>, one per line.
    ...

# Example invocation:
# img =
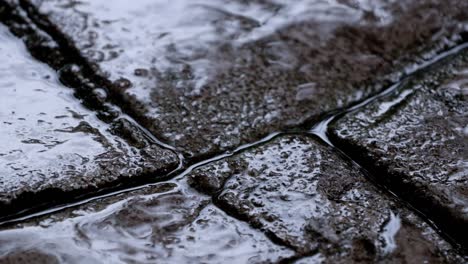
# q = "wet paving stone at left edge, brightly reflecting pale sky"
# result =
<box><xmin>0</xmin><ymin>25</ymin><xmax>178</xmax><ymax>217</ymax></box>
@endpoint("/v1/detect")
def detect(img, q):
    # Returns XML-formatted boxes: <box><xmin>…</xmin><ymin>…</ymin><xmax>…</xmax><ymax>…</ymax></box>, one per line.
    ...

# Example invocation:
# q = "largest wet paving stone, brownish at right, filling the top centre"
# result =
<box><xmin>18</xmin><ymin>0</ymin><xmax>468</xmax><ymax>158</ymax></box>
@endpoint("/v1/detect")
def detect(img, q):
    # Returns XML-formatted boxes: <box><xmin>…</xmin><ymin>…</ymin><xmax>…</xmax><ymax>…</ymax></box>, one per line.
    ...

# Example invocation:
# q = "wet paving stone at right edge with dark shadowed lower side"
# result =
<box><xmin>332</xmin><ymin>49</ymin><xmax>468</xmax><ymax>245</ymax></box>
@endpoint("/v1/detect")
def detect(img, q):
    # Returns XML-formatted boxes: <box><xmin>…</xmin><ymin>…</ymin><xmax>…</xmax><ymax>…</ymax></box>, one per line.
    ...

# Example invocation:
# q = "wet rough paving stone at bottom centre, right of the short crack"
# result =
<box><xmin>189</xmin><ymin>136</ymin><xmax>463</xmax><ymax>263</ymax></box>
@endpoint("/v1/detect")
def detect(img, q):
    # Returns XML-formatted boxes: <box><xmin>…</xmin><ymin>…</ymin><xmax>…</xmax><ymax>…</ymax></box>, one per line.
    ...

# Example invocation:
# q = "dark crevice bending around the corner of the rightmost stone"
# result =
<box><xmin>326</xmin><ymin>46</ymin><xmax>468</xmax><ymax>255</ymax></box>
